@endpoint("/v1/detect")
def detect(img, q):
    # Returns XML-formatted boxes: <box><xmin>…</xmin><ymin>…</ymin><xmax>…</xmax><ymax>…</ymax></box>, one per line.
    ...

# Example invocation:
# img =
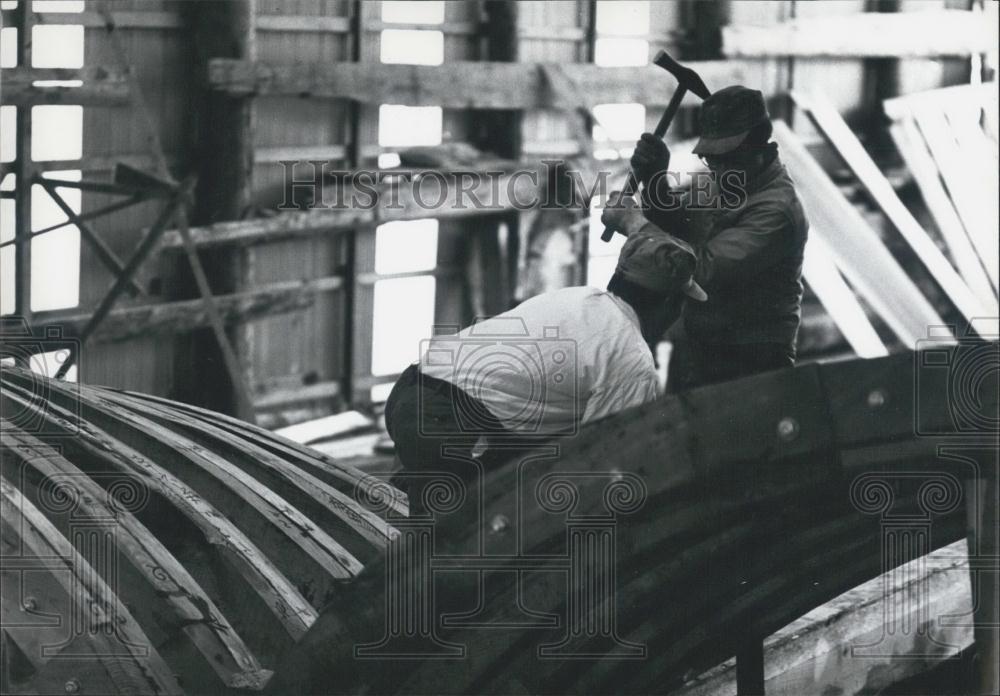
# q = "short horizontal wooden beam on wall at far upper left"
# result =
<box><xmin>2</xmin><ymin>66</ymin><xmax>129</xmax><ymax>106</ymax></box>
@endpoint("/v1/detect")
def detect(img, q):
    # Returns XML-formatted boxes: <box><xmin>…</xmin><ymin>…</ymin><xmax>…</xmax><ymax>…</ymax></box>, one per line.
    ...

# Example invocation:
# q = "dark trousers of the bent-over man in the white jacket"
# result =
<box><xmin>385</xmin><ymin>365</ymin><xmax>509</xmax><ymax>515</ymax></box>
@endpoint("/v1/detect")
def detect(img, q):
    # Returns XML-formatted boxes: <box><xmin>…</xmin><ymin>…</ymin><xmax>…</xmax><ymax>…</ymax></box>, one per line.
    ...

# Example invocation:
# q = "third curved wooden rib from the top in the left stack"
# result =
<box><xmin>0</xmin><ymin>372</ymin><xmax>363</xmax><ymax>584</ymax></box>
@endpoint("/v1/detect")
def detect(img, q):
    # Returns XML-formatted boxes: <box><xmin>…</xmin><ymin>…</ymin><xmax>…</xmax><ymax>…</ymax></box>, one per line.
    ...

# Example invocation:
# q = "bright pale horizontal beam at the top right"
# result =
<box><xmin>722</xmin><ymin>10</ymin><xmax>997</xmax><ymax>58</ymax></box>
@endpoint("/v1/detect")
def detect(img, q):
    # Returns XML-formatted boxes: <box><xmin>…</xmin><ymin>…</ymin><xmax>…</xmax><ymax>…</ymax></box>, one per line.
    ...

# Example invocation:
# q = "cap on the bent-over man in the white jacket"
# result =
<box><xmin>616</xmin><ymin>225</ymin><xmax>708</xmax><ymax>302</ymax></box>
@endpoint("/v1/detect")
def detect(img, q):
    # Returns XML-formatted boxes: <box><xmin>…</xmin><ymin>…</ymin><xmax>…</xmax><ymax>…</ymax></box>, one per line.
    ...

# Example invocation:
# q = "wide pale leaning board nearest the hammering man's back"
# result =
<box><xmin>774</xmin><ymin>120</ymin><xmax>944</xmax><ymax>348</ymax></box>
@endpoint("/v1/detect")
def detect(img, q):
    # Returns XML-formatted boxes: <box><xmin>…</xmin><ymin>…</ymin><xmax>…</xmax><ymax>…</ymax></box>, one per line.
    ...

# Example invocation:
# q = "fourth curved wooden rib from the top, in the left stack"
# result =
<box><xmin>0</xmin><ymin>378</ymin><xmax>317</xmax><ymax>640</ymax></box>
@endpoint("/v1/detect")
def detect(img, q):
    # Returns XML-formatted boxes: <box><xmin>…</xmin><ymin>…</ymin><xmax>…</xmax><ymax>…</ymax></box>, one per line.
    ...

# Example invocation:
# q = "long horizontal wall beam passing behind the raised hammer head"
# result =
<box><xmin>208</xmin><ymin>59</ymin><xmax>756</xmax><ymax>109</ymax></box>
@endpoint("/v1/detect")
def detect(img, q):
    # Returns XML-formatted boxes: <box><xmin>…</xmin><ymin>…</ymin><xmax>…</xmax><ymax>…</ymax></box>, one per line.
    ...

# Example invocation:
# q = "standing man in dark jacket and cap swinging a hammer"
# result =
<box><xmin>631</xmin><ymin>86</ymin><xmax>809</xmax><ymax>390</ymax></box>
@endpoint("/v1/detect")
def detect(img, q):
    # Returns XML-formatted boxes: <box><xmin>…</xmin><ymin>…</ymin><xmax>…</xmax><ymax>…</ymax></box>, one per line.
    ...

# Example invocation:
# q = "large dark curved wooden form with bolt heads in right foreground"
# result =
<box><xmin>273</xmin><ymin>348</ymin><xmax>996</xmax><ymax>693</ymax></box>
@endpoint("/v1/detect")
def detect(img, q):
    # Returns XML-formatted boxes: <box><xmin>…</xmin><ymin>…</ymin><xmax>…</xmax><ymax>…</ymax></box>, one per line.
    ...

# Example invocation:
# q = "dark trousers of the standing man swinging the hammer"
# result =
<box><xmin>667</xmin><ymin>340</ymin><xmax>795</xmax><ymax>392</ymax></box>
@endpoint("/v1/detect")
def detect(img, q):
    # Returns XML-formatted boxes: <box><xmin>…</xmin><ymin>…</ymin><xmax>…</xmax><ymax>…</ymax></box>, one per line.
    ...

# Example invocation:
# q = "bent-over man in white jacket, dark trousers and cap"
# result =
<box><xmin>385</xmin><ymin>206</ymin><xmax>704</xmax><ymax>505</ymax></box>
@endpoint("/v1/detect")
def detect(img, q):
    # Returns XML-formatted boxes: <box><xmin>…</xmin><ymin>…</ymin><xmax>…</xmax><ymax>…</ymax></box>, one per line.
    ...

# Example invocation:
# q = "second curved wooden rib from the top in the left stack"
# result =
<box><xmin>95</xmin><ymin>390</ymin><xmax>398</xmax><ymax>548</ymax></box>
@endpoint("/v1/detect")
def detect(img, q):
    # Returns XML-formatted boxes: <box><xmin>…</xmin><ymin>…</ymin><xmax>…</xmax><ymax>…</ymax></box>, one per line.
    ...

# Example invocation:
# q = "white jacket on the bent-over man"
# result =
<box><xmin>420</xmin><ymin>287</ymin><xmax>659</xmax><ymax>435</ymax></box>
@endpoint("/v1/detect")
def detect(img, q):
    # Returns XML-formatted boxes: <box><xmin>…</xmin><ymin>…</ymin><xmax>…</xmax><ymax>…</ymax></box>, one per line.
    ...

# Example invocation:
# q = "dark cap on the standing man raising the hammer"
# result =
<box><xmin>694</xmin><ymin>85</ymin><xmax>771</xmax><ymax>155</ymax></box>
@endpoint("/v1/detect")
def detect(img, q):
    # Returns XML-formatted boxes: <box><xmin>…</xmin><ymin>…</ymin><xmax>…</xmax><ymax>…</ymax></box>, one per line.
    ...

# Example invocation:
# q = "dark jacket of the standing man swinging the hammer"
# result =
<box><xmin>646</xmin><ymin>146</ymin><xmax>809</xmax><ymax>355</ymax></box>
